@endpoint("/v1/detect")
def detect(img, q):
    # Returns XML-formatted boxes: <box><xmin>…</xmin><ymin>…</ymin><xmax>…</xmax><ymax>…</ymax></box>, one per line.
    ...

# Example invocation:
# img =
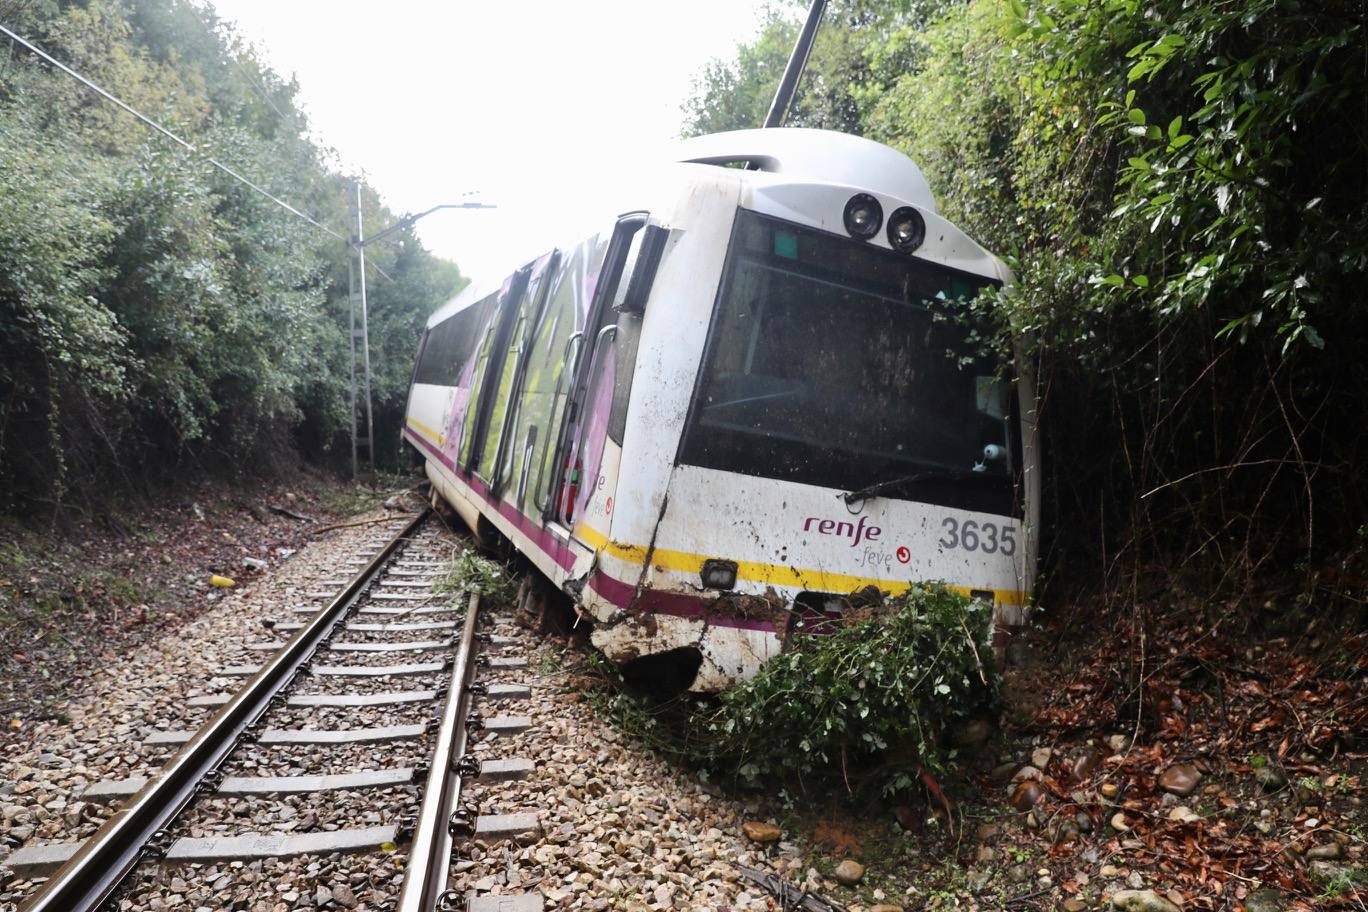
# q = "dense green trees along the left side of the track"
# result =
<box><xmin>0</xmin><ymin>0</ymin><xmax>462</xmax><ymax>513</ymax></box>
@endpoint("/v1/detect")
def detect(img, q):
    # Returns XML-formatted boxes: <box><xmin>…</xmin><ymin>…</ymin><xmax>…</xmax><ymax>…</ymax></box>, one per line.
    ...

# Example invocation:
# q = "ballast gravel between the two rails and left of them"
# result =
<box><xmin>0</xmin><ymin>524</ymin><xmax>440</xmax><ymax>912</ymax></box>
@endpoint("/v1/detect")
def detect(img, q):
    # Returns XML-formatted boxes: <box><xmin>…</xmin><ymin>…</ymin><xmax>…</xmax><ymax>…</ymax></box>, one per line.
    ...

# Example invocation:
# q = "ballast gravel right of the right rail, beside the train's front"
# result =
<box><xmin>450</xmin><ymin>623</ymin><xmax>807</xmax><ymax>912</ymax></box>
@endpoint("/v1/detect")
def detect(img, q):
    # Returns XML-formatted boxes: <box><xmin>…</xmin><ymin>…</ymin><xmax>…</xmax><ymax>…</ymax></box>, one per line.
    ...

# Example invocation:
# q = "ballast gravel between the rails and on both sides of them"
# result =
<box><xmin>0</xmin><ymin>519</ymin><xmax>831</xmax><ymax>912</ymax></box>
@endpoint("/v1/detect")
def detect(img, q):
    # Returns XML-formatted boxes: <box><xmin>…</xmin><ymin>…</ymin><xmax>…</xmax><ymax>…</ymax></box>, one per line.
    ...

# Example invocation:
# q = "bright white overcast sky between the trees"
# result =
<box><xmin>211</xmin><ymin>0</ymin><xmax>765</xmax><ymax>285</ymax></box>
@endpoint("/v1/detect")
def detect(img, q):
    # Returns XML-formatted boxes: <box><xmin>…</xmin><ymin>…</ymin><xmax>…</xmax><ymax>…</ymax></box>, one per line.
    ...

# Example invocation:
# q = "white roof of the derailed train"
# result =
<box><xmin>428</xmin><ymin>127</ymin><xmax>952</xmax><ymax>327</ymax></box>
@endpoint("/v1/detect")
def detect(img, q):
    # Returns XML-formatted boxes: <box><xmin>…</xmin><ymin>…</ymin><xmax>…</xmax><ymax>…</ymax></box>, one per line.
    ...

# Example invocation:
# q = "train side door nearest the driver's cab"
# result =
<box><xmin>550</xmin><ymin>213</ymin><xmax>654</xmax><ymax>546</ymax></box>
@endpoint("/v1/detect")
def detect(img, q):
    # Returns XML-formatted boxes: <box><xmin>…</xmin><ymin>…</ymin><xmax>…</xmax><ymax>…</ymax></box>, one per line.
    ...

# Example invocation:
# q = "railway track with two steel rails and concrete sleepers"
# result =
<box><xmin>5</xmin><ymin>514</ymin><xmax>543</xmax><ymax>912</ymax></box>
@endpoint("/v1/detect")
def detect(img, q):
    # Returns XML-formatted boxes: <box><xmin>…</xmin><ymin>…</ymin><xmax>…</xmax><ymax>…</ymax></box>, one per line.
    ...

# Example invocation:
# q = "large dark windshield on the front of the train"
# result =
<box><xmin>680</xmin><ymin>211</ymin><xmax>1019</xmax><ymax>515</ymax></box>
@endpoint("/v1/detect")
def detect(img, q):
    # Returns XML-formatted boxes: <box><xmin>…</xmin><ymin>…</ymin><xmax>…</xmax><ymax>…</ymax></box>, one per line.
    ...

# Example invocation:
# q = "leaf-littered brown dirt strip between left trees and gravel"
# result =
<box><xmin>0</xmin><ymin>474</ymin><xmax>404</xmax><ymax>734</ymax></box>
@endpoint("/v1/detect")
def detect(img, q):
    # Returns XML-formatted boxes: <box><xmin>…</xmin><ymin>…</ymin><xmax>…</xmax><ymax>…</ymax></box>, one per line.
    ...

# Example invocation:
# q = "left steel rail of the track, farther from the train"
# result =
<box><xmin>22</xmin><ymin>510</ymin><xmax>431</xmax><ymax>912</ymax></box>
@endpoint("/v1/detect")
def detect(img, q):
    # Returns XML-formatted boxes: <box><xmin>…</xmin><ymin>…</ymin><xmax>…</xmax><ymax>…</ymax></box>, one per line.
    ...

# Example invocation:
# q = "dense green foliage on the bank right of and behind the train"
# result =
<box><xmin>685</xmin><ymin>0</ymin><xmax>1368</xmax><ymax>603</ymax></box>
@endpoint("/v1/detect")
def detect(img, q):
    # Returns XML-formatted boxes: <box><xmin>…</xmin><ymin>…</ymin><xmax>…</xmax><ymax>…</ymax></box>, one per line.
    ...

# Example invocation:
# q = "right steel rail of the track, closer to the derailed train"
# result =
<box><xmin>394</xmin><ymin>592</ymin><xmax>480</xmax><ymax>912</ymax></box>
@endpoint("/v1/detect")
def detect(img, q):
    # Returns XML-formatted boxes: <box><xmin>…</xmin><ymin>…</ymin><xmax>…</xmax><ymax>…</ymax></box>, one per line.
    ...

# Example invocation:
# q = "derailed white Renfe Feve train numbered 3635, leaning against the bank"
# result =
<box><xmin>404</xmin><ymin>130</ymin><xmax>1040</xmax><ymax>690</ymax></box>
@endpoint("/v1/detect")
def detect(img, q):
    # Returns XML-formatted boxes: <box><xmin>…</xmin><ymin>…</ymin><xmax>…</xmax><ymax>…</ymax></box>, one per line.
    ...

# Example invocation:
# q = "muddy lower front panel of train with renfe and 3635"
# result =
<box><xmin>584</xmin><ymin>465</ymin><xmax>1029</xmax><ymax>689</ymax></box>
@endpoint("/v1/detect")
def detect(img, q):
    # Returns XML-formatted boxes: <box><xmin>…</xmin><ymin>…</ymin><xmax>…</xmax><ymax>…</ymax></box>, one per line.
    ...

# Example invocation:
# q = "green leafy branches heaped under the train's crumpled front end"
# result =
<box><xmin>595</xmin><ymin>584</ymin><xmax>997</xmax><ymax>793</ymax></box>
